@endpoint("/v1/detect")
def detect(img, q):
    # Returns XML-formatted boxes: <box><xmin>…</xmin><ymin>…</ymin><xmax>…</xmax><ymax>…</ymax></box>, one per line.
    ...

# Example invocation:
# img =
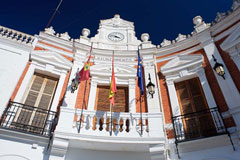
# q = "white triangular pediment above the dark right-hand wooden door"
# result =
<box><xmin>160</xmin><ymin>54</ymin><xmax>203</xmax><ymax>76</ymax></box>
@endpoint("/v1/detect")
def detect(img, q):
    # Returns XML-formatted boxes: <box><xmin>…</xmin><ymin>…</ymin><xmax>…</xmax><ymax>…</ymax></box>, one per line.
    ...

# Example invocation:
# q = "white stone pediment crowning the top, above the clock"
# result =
<box><xmin>100</xmin><ymin>14</ymin><xmax>134</xmax><ymax>28</ymax></box>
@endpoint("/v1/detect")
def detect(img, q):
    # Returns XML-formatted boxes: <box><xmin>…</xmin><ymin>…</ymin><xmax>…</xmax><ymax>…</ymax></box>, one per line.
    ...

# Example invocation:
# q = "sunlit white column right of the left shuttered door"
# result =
<box><xmin>51</xmin><ymin>71</ymin><xmax>67</xmax><ymax>111</ymax></box>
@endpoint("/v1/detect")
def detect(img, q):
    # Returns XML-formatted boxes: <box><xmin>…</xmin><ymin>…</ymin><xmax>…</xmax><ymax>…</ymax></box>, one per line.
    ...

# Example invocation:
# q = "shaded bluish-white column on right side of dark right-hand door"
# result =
<box><xmin>197</xmin><ymin>68</ymin><xmax>217</xmax><ymax>108</ymax></box>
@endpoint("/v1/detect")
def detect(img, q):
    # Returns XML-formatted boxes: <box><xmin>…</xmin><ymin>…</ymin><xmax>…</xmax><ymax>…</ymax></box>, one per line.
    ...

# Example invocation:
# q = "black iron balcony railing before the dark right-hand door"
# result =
<box><xmin>172</xmin><ymin>107</ymin><xmax>226</xmax><ymax>143</ymax></box>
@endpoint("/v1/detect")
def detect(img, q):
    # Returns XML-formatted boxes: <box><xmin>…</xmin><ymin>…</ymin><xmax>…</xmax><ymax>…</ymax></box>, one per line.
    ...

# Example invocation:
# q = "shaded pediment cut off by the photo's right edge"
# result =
<box><xmin>221</xmin><ymin>26</ymin><xmax>240</xmax><ymax>51</ymax></box>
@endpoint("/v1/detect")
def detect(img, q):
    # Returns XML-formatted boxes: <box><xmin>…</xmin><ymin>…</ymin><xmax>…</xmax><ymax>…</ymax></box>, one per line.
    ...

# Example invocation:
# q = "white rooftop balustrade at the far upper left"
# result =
<box><xmin>0</xmin><ymin>26</ymin><xmax>34</xmax><ymax>44</ymax></box>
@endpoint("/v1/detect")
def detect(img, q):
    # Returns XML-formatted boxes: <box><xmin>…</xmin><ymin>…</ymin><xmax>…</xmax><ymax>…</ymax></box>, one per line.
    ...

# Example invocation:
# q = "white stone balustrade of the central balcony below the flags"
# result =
<box><xmin>73</xmin><ymin>110</ymin><xmax>150</xmax><ymax>137</ymax></box>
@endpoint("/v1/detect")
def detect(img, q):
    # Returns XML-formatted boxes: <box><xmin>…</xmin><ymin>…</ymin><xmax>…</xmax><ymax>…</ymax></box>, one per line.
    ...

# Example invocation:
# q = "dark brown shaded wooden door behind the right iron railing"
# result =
<box><xmin>175</xmin><ymin>78</ymin><xmax>216</xmax><ymax>138</ymax></box>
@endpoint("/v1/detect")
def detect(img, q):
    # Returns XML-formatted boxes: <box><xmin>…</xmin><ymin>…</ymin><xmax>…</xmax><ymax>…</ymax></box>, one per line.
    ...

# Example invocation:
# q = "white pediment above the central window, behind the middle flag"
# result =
<box><xmin>90</xmin><ymin>63</ymin><xmax>137</xmax><ymax>78</ymax></box>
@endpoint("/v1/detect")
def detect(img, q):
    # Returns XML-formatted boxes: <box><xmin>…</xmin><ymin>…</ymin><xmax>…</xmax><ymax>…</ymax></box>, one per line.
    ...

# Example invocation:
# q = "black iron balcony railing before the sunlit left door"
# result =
<box><xmin>0</xmin><ymin>101</ymin><xmax>57</xmax><ymax>137</ymax></box>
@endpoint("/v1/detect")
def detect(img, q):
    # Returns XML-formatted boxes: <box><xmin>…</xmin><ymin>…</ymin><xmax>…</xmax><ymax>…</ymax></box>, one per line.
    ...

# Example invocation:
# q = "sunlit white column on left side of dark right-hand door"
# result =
<box><xmin>166</xmin><ymin>79</ymin><xmax>181</xmax><ymax>116</ymax></box>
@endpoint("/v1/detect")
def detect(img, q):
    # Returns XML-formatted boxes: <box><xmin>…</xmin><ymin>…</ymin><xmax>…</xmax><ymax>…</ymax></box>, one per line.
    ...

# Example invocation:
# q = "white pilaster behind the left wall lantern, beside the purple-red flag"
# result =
<box><xmin>62</xmin><ymin>61</ymin><xmax>83</xmax><ymax>108</ymax></box>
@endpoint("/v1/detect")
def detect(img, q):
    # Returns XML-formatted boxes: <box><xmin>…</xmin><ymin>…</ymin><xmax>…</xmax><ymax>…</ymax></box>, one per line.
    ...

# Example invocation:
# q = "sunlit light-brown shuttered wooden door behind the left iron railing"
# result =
<box><xmin>16</xmin><ymin>74</ymin><xmax>57</xmax><ymax>132</ymax></box>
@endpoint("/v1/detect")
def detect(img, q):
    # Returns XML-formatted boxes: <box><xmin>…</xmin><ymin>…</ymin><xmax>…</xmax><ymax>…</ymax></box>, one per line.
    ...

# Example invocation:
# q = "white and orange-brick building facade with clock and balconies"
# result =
<box><xmin>0</xmin><ymin>1</ymin><xmax>240</xmax><ymax>160</ymax></box>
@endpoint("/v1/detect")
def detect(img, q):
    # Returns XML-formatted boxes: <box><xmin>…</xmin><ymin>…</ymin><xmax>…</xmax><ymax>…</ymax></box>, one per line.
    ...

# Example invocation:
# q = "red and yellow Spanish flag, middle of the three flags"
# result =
<box><xmin>109</xmin><ymin>54</ymin><xmax>117</xmax><ymax>105</ymax></box>
